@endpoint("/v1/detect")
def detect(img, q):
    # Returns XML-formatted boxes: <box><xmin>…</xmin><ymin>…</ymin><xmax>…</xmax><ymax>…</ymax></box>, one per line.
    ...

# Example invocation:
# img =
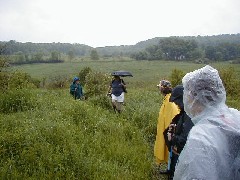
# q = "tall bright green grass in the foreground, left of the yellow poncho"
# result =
<box><xmin>0</xmin><ymin>90</ymin><xmax>156</xmax><ymax>179</ymax></box>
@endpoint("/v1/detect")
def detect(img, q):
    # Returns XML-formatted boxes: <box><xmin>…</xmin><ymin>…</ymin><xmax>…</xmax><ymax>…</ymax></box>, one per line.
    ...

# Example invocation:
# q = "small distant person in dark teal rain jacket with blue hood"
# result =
<box><xmin>70</xmin><ymin>77</ymin><xmax>83</xmax><ymax>99</ymax></box>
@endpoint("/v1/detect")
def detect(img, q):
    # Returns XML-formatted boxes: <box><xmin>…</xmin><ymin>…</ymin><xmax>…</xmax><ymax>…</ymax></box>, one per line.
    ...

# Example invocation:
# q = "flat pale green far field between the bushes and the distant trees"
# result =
<box><xmin>12</xmin><ymin>60</ymin><xmax>240</xmax><ymax>88</ymax></box>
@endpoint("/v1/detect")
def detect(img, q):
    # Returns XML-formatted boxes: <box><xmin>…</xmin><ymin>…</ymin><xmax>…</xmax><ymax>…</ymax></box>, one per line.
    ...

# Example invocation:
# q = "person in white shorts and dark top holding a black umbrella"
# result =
<box><xmin>107</xmin><ymin>71</ymin><xmax>132</xmax><ymax>113</ymax></box>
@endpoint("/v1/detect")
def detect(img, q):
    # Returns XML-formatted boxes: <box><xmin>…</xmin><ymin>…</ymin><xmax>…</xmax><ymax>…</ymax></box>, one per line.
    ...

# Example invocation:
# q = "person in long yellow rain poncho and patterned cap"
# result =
<box><xmin>154</xmin><ymin>80</ymin><xmax>180</xmax><ymax>170</ymax></box>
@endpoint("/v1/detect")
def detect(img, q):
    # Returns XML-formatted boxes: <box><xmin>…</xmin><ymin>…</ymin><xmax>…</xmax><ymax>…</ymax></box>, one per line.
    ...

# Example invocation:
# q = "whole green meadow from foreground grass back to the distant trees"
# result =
<box><xmin>0</xmin><ymin>59</ymin><xmax>240</xmax><ymax>180</ymax></box>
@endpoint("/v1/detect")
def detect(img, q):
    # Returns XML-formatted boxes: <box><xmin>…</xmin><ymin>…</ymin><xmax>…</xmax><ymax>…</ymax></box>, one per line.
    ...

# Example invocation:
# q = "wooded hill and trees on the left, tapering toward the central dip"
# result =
<box><xmin>0</xmin><ymin>40</ymin><xmax>93</xmax><ymax>64</ymax></box>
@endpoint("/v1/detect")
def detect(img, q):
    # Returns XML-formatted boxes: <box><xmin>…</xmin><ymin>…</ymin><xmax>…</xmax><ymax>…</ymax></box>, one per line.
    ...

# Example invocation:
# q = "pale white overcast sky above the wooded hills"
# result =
<box><xmin>0</xmin><ymin>0</ymin><xmax>240</xmax><ymax>47</ymax></box>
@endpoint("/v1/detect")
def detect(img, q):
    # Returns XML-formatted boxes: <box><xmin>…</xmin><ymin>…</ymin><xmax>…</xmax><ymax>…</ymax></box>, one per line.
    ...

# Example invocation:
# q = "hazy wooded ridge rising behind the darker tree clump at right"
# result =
<box><xmin>96</xmin><ymin>34</ymin><xmax>240</xmax><ymax>59</ymax></box>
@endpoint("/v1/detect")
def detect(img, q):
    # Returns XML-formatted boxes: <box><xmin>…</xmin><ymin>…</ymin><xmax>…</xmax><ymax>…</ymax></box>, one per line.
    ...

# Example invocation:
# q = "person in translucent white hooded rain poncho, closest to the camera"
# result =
<box><xmin>174</xmin><ymin>65</ymin><xmax>240</xmax><ymax>180</ymax></box>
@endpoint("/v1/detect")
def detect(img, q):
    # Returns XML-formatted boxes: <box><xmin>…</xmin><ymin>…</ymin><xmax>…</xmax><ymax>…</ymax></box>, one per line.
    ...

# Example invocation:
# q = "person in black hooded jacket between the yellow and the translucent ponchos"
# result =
<box><xmin>164</xmin><ymin>85</ymin><xmax>193</xmax><ymax>179</ymax></box>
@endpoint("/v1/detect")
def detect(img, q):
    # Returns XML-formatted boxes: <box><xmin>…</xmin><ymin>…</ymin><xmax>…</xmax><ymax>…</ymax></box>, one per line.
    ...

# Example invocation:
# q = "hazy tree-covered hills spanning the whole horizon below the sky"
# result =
<box><xmin>0</xmin><ymin>33</ymin><xmax>240</xmax><ymax>64</ymax></box>
